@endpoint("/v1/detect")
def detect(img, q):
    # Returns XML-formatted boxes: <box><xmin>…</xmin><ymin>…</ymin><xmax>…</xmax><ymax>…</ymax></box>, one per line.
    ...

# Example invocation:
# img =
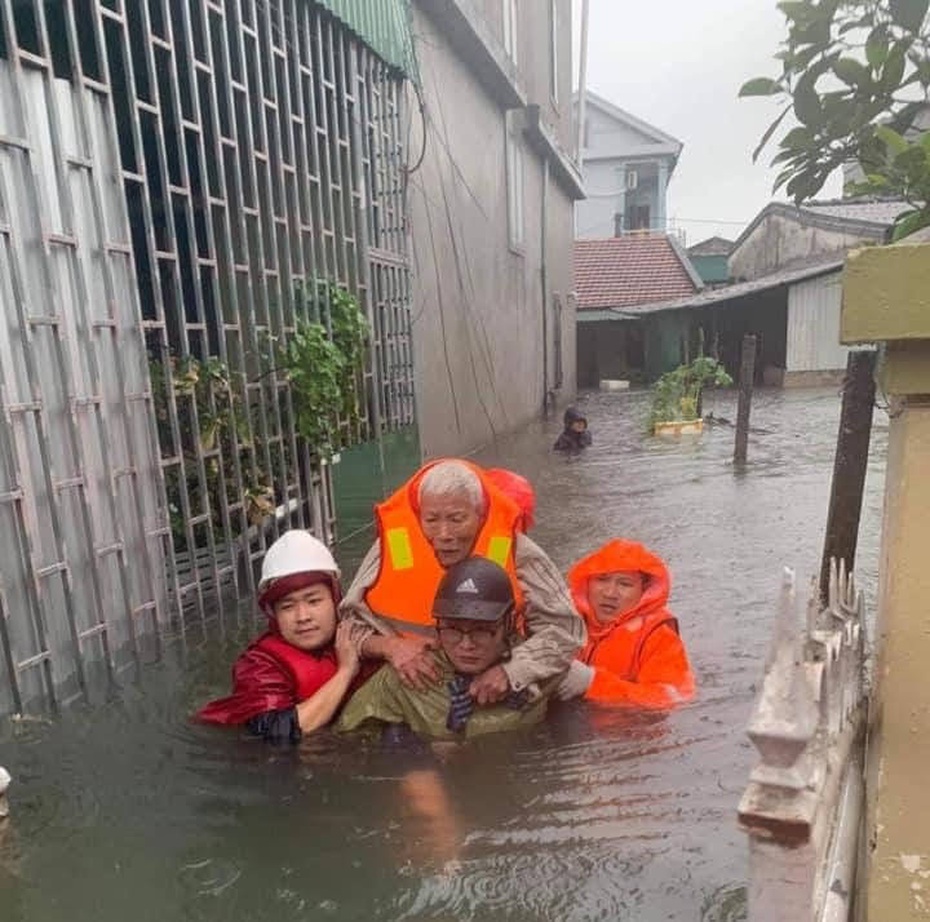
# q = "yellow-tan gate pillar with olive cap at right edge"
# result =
<box><xmin>841</xmin><ymin>230</ymin><xmax>930</xmax><ymax>922</ymax></box>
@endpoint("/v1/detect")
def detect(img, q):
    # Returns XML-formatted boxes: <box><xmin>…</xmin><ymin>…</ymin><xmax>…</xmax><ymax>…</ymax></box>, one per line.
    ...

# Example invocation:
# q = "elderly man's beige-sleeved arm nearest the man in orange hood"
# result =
<box><xmin>504</xmin><ymin>534</ymin><xmax>587</xmax><ymax>691</ymax></box>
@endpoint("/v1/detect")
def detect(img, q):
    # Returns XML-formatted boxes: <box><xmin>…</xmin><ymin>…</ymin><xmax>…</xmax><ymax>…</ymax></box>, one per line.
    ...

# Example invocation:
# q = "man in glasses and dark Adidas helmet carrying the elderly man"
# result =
<box><xmin>337</xmin><ymin>557</ymin><xmax>560</xmax><ymax>739</ymax></box>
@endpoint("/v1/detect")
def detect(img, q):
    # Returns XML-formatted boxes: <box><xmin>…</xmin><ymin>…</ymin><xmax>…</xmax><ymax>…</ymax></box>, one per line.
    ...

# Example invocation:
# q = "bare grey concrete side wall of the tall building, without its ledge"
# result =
<box><xmin>409</xmin><ymin>2</ymin><xmax>575</xmax><ymax>457</ymax></box>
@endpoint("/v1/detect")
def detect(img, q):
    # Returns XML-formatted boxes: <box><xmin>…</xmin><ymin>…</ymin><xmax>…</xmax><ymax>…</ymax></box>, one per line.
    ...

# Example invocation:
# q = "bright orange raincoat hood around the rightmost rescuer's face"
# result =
<box><xmin>568</xmin><ymin>538</ymin><xmax>671</xmax><ymax>640</ymax></box>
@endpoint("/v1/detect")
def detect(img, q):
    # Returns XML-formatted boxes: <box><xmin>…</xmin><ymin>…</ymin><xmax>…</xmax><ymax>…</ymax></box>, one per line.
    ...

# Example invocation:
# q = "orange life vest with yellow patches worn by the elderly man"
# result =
<box><xmin>365</xmin><ymin>460</ymin><xmax>523</xmax><ymax>632</ymax></box>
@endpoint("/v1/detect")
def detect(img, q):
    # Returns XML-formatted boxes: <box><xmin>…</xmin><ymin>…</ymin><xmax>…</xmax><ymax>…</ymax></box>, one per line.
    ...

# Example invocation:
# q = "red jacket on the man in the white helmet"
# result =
<box><xmin>197</xmin><ymin>631</ymin><xmax>337</xmax><ymax>725</ymax></box>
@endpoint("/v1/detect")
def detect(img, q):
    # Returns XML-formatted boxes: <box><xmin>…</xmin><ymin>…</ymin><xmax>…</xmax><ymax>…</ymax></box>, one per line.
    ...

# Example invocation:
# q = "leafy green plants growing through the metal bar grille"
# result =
<box><xmin>149</xmin><ymin>282</ymin><xmax>368</xmax><ymax>548</ymax></box>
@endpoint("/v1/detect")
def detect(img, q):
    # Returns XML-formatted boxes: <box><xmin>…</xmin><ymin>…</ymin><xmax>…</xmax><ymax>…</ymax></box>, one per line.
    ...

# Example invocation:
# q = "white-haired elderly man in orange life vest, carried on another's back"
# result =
<box><xmin>342</xmin><ymin>460</ymin><xmax>586</xmax><ymax>705</ymax></box>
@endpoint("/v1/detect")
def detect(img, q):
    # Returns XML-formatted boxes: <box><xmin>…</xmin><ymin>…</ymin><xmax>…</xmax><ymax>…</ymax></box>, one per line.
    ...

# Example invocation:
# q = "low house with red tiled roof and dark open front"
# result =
<box><xmin>575</xmin><ymin>234</ymin><xmax>702</xmax><ymax>387</ymax></box>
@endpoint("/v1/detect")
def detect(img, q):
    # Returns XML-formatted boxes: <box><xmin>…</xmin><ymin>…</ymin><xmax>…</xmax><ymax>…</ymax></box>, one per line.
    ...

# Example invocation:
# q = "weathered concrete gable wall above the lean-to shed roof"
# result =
<box><xmin>730</xmin><ymin>213</ymin><xmax>870</xmax><ymax>281</ymax></box>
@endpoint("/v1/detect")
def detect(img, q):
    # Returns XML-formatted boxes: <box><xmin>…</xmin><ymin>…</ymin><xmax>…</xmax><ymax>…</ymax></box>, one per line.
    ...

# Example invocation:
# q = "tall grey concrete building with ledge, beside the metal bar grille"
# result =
<box><xmin>409</xmin><ymin>0</ymin><xmax>582</xmax><ymax>456</ymax></box>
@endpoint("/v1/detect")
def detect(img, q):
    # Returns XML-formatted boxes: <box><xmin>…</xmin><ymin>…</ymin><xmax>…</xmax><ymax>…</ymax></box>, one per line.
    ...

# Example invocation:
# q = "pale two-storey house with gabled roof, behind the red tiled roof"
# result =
<box><xmin>575</xmin><ymin>92</ymin><xmax>682</xmax><ymax>239</ymax></box>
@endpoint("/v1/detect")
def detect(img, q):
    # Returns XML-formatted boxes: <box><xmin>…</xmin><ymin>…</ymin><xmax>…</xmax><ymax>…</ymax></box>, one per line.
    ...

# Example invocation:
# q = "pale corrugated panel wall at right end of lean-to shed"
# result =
<box><xmin>785</xmin><ymin>272</ymin><xmax>849</xmax><ymax>380</ymax></box>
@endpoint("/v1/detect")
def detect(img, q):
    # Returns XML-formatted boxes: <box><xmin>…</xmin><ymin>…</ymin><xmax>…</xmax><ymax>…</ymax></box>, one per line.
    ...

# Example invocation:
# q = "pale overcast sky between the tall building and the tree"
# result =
<box><xmin>574</xmin><ymin>0</ymin><xmax>840</xmax><ymax>246</ymax></box>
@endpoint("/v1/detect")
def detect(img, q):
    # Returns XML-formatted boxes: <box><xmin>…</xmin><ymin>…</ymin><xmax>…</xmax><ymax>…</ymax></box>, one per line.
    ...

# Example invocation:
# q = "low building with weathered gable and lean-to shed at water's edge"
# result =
<box><xmin>600</xmin><ymin>200</ymin><xmax>905</xmax><ymax>386</ymax></box>
